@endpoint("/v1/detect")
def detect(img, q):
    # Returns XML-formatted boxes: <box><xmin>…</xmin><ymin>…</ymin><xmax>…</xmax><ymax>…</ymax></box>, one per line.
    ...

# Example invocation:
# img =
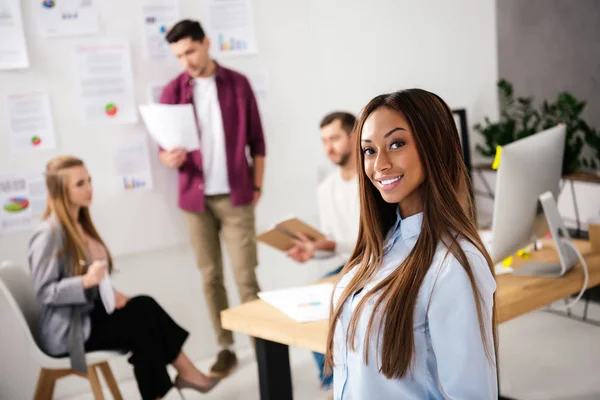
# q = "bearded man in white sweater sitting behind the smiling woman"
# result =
<box><xmin>288</xmin><ymin>112</ymin><xmax>360</xmax><ymax>390</ymax></box>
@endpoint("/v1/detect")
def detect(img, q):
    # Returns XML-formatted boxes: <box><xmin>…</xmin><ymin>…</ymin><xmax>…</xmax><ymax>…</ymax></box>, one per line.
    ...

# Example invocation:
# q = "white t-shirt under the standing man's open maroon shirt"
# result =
<box><xmin>194</xmin><ymin>75</ymin><xmax>230</xmax><ymax>196</ymax></box>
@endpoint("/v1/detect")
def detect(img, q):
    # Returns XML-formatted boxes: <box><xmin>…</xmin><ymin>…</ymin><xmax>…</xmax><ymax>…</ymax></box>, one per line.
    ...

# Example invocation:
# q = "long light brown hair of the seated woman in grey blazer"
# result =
<box><xmin>44</xmin><ymin>156</ymin><xmax>112</xmax><ymax>276</ymax></box>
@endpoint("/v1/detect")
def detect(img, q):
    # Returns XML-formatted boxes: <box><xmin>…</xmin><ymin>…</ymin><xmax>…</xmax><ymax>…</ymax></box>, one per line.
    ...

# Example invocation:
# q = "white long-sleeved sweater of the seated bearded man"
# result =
<box><xmin>318</xmin><ymin>168</ymin><xmax>360</xmax><ymax>262</ymax></box>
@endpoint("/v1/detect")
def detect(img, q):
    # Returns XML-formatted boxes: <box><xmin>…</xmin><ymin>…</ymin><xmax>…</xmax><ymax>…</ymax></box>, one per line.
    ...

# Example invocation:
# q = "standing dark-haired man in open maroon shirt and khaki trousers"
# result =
<box><xmin>159</xmin><ymin>20</ymin><xmax>265</xmax><ymax>377</ymax></box>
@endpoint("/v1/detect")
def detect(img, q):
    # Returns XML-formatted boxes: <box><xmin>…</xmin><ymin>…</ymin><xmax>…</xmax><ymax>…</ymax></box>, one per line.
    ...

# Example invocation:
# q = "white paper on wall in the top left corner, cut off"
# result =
<box><xmin>0</xmin><ymin>0</ymin><xmax>29</xmax><ymax>69</ymax></box>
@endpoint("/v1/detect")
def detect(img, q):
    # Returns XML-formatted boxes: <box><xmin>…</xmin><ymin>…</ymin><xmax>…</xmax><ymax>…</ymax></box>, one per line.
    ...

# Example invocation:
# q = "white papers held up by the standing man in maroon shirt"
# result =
<box><xmin>140</xmin><ymin>104</ymin><xmax>200</xmax><ymax>151</ymax></box>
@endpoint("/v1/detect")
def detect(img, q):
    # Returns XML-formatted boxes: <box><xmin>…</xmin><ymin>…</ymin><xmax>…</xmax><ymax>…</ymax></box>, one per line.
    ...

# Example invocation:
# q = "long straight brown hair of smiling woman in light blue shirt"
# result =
<box><xmin>326</xmin><ymin>89</ymin><xmax>496</xmax><ymax>379</ymax></box>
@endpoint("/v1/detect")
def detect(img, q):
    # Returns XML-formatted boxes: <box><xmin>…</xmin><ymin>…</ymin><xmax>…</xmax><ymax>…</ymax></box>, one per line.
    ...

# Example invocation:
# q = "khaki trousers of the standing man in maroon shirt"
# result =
<box><xmin>184</xmin><ymin>195</ymin><xmax>260</xmax><ymax>346</ymax></box>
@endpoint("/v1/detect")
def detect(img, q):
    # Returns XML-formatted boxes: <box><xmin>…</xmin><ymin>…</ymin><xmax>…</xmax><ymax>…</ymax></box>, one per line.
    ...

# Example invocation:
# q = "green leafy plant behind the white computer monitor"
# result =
<box><xmin>474</xmin><ymin>79</ymin><xmax>600</xmax><ymax>175</ymax></box>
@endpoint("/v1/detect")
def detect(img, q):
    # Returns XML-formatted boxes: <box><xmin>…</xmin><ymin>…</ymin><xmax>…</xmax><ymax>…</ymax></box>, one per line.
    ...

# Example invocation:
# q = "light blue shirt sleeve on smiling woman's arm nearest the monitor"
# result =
<box><xmin>428</xmin><ymin>252</ymin><xmax>498</xmax><ymax>400</ymax></box>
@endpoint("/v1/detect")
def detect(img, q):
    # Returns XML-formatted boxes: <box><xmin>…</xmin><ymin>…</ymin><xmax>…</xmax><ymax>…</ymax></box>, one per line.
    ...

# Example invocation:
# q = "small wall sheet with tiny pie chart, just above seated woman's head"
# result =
<box><xmin>6</xmin><ymin>92</ymin><xmax>56</xmax><ymax>154</ymax></box>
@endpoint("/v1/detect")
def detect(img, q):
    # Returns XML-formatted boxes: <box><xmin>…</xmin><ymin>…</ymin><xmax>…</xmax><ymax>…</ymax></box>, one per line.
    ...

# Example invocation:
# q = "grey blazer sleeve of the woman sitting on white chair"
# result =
<box><xmin>27</xmin><ymin>223</ymin><xmax>86</xmax><ymax>306</ymax></box>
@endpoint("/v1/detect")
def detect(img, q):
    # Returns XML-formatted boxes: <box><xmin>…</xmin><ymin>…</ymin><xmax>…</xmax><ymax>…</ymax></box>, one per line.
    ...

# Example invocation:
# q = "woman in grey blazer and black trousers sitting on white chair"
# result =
<box><xmin>28</xmin><ymin>156</ymin><xmax>218</xmax><ymax>399</ymax></box>
